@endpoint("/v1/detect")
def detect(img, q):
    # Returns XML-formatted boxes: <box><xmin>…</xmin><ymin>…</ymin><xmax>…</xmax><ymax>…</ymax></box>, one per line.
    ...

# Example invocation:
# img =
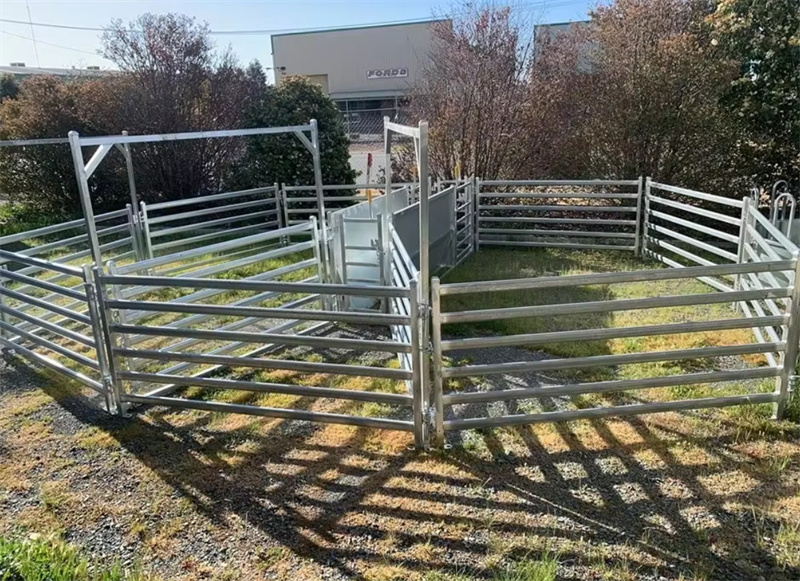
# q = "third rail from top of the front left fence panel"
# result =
<box><xmin>109</xmin><ymin>324</ymin><xmax>411</xmax><ymax>353</ymax></box>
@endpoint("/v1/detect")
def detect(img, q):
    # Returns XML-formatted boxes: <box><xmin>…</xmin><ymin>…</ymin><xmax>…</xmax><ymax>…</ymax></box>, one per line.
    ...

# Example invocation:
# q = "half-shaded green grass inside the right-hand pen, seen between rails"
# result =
<box><xmin>442</xmin><ymin>249</ymin><xmax>764</xmax><ymax>388</ymax></box>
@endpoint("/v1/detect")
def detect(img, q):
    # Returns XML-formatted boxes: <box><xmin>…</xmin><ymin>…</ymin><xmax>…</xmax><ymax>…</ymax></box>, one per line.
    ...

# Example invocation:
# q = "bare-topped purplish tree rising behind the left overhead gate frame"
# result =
<box><xmin>101</xmin><ymin>14</ymin><xmax>265</xmax><ymax>201</ymax></box>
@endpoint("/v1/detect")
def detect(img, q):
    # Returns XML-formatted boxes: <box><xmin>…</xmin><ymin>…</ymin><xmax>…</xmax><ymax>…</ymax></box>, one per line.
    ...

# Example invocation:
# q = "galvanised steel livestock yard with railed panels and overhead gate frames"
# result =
<box><xmin>0</xmin><ymin>120</ymin><xmax>800</xmax><ymax>454</ymax></box>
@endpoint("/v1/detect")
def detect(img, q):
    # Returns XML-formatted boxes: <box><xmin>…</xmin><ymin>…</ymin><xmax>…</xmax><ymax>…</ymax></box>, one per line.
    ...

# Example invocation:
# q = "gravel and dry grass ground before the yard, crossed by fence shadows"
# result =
<box><xmin>0</xmin><ymin>328</ymin><xmax>800</xmax><ymax>581</ymax></box>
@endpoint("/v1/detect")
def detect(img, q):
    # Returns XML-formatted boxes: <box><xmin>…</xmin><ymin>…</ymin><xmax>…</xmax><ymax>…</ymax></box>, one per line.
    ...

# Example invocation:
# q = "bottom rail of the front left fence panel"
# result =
<box><xmin>122</xmin><ymin>394</ymin><xmax>414</xmax><ymax>432</ymax></box>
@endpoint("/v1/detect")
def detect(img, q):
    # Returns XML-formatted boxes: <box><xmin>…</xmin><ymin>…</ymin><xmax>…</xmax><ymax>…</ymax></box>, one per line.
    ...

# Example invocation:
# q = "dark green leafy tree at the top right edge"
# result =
<box><xmin>708</xmin><ymin>0</ymin><xmax>800</xmax><ymax>192</ymax></box>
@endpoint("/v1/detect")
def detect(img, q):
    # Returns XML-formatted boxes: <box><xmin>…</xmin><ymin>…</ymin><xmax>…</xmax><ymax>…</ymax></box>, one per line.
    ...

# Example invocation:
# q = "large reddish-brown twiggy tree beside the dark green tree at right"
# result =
<box><xmin>529</xmin><ymin>0</ymin><xmax>746</xmax><ymax>195</ymax></box>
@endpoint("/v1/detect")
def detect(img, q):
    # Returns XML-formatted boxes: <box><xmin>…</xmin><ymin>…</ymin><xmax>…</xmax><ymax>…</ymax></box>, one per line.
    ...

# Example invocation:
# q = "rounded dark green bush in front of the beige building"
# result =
<box><xmin>234</xmin><ymin>75</ymin><xmax>356</xmax><ymax>187</ymax></box>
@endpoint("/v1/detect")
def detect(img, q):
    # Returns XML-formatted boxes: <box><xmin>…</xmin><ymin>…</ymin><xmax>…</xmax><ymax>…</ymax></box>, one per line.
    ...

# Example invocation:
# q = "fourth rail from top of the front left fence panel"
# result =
<box><xmin>114</xmin><ymin>349</ymin><xmax>411</xmax><ymax>380</ymax></box>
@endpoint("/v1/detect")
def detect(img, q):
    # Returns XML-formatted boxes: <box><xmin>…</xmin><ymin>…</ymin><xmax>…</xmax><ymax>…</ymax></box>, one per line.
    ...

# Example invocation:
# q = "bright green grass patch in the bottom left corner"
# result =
<box><xmin>0</xmin><ymin>535</ymin><xmax>153</xmax><ymax>581</ymax></box>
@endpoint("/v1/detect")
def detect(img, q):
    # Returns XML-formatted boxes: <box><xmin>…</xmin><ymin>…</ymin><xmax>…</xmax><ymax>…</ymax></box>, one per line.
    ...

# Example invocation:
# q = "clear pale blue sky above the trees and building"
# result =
<box><xmin>0</xmin><ymin>0</ymin><xmax>596</xmax><ymax>82</ymax></box>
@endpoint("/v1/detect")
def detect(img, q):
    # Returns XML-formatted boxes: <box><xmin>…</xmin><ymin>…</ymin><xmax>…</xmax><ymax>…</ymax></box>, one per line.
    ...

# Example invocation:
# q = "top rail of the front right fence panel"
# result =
<box><xmin>441</xmin><ymin>260</ymin><xmax>795</xmax><ymax>295</ymax></box>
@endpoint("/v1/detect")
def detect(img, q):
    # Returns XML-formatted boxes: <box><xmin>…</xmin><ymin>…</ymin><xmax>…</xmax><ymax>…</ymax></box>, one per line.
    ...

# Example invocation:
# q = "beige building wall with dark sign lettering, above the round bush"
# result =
<box><xmin>272</xmin><ymin>22</ymin><xmax>440</xmax><ymax>99</ymax></box>
